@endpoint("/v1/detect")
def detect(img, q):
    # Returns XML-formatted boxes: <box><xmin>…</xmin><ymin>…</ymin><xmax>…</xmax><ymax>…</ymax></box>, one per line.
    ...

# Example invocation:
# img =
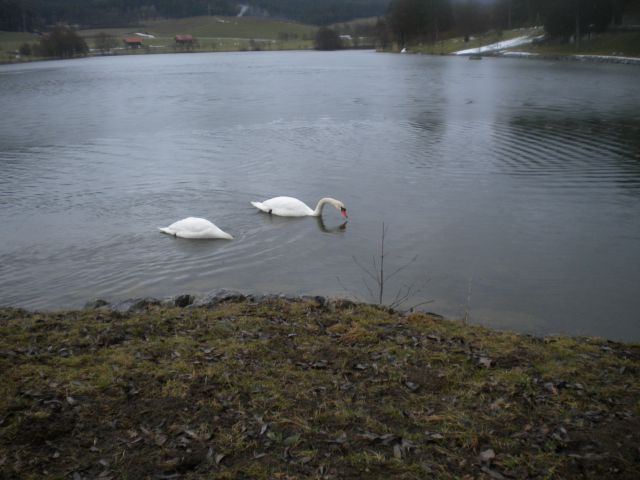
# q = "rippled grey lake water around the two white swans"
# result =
<box><xmin>0</xmin><ymin>52</ymin><xmax>640</xmax><ymax>341</ymax></box>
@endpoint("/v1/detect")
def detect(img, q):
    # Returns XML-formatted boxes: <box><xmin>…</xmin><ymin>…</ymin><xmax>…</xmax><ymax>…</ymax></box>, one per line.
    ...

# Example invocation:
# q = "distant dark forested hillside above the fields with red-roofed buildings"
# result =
<box><xmin>0</xmin><ymin>0</ymin><xmax>389</xmax><ymax>31</ymax></box>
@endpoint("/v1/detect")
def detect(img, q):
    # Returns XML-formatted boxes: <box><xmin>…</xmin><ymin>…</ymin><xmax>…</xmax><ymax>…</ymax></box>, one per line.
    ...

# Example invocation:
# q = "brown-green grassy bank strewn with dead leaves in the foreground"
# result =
<box><xmin>0</xmin><ymin>299</ymin><xmax>640</xmax><ymax>479</ymax></box>
